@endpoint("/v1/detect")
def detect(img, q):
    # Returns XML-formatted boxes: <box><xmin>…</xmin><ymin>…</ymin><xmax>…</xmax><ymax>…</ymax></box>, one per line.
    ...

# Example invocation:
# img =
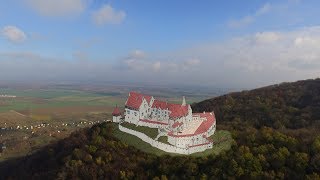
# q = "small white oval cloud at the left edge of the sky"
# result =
<box><xmin>1</xmin><ymin>26</ymin><xmax>27</xmax><ymax>43</ymax></box>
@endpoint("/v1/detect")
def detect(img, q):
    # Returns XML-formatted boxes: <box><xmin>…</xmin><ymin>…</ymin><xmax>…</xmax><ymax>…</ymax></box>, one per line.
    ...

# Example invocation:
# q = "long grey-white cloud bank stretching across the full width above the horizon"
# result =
<box><xmin>0</xmin><ymin>26</ymin><xmax>320</xmax><ymax>88</ymax></box>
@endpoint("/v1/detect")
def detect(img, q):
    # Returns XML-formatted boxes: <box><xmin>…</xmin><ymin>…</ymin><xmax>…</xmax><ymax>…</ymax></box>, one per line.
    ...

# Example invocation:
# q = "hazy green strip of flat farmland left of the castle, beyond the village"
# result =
<box><xmin>0</xmin><ymin>89</ymin><xmax>125</xmax><ymax>112</ymax></box>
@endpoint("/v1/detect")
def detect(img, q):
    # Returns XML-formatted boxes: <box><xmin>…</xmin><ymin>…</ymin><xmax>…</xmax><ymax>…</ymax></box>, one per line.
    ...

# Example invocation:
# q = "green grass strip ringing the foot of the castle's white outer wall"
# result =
<box><xmin>113</xmin><ymin>123</ymin><xmax>233</xmax><ymax>157</ymax></box>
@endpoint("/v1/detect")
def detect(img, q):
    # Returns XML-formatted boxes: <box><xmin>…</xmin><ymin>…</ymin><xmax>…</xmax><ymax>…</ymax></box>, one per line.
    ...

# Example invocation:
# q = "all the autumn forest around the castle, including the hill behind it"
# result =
<box><xmin>0</xmin><ymin>79</ymin><xmax>320</xmax><ymax>179</ymax></box>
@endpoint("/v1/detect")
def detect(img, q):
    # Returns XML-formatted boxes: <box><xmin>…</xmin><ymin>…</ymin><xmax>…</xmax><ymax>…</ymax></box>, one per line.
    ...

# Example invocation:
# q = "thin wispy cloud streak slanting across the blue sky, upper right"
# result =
<box><xmin>228</xmin><ymin>3</ymin><xmax>272</xmax><ymax>28</ymax></box>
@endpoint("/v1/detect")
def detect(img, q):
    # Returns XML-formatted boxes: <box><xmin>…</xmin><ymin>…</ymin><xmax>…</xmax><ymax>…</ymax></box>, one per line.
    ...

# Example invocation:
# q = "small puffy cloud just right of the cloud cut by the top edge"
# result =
<box><xmin>92</xmin><ymin>4</ymin><xmax>126</xmax><ymax>25</ymax></box>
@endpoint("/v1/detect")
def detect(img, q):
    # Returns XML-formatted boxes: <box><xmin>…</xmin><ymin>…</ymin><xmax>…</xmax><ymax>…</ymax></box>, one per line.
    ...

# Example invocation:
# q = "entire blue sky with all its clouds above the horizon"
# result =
<box><xmin>0</xmin><ymin>0</ymin><xmax>320</xmax><ymax>87</ymax></box>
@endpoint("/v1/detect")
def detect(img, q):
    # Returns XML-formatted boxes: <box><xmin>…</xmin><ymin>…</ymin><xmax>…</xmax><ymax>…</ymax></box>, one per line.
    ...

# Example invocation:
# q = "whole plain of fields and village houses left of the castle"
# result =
<box><xmin>0</xmin><ymin>88</ymin><xmax>125</xmax><ymax>161</ymax></box>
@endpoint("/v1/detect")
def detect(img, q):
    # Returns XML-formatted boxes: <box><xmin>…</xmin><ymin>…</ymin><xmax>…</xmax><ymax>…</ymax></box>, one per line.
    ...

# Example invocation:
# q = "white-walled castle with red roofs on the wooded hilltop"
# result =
<box><xmin>112</xmin><ymin>92</ymin><xmax>216</xmax><ymax>154</ymax></box>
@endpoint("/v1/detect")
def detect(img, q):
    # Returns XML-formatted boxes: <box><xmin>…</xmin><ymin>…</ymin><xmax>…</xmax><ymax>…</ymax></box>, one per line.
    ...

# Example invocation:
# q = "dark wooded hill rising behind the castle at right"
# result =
<box><xmin>192</xmin><ymin>78</ymin><xmax>320</xmax><ymax>129</ymax></box>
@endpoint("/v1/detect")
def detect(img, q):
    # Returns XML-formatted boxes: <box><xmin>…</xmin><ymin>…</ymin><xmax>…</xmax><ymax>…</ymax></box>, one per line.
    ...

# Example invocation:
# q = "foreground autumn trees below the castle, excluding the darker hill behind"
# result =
<box><xmin>0</xmin><ymin>123</ymin><xmax>320</xmax><ymax>179</ymax></box>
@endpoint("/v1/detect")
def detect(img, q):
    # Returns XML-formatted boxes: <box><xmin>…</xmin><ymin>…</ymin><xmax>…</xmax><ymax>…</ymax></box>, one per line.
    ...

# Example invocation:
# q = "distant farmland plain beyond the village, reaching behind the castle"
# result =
<box><xmin>0</xmin><ymin>86</ymin><xmax>218</xmax><ymax>127</ymax></box>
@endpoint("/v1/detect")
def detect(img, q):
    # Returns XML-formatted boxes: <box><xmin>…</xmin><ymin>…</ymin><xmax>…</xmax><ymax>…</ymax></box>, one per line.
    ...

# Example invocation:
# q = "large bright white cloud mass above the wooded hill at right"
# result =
<box><xmin>171</xmin><ymin>27</ymin><xmax>320</xmax><ymax>86</ymax></box>
